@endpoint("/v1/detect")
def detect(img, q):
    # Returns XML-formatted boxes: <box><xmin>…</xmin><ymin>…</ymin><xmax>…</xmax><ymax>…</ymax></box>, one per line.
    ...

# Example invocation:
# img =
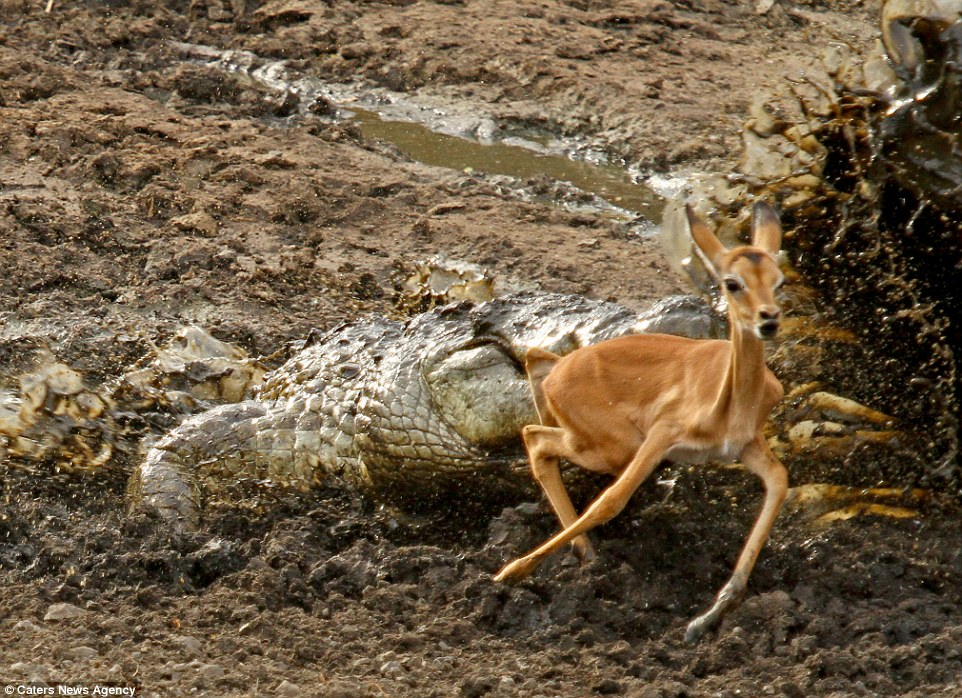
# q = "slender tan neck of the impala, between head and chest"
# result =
<box><xmin>713</xmin><ymin>318</ymin><xmax>765</xmax><ymax>422</ymax></box>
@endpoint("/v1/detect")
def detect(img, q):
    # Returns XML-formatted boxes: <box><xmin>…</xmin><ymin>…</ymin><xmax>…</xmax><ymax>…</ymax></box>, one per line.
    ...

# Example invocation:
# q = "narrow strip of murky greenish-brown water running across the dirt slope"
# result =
<box><xmin>172</xmin><ymin>42</ymin><xmax>665</xmax><ymax>224</ymax></box>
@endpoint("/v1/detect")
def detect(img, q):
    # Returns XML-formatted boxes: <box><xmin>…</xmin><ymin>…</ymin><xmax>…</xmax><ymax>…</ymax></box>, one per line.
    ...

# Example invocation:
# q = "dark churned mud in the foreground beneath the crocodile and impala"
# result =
<box><xmin>3</xmin><ymin>462</ymin><xmax>962</xmax><ymax>696</ymax></box>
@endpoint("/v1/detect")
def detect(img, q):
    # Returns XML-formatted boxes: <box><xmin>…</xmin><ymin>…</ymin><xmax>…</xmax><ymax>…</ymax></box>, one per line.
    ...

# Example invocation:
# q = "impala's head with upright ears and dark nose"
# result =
<box><xmin>686</xmin><ymin>202</ymin><xmax>784</xmax><ymax>339</ymax></box>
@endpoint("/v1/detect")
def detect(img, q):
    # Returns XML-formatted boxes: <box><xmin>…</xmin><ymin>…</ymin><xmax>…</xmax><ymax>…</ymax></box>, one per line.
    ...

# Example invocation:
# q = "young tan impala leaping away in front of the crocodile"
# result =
<box><xmin>495</xmin><ymin>203</ymin><xmax>788</xmax><ymax>642</ymax></box>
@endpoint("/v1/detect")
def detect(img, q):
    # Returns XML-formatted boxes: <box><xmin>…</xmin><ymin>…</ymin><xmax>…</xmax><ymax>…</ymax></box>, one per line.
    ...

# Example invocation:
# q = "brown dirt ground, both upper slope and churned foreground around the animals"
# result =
<box><xmin>0</xmin><ymin>0</ymin><xmax>962</xmax><ymax>698</ymax></box>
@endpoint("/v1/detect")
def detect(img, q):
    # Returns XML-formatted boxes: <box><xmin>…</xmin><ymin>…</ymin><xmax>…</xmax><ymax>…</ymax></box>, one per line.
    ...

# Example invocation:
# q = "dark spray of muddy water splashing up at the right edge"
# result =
<box><xmin>704</xmin><ymin>2</ymin><xmax>962</xmax><ymax>492</ymax></box>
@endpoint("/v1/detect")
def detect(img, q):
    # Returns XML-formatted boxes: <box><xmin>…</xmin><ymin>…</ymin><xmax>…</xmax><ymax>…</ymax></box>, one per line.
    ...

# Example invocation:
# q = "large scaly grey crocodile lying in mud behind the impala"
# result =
<box><xmin>128</xmin><ymin>292</ymin><xmax>724</xmax><ymax>528</ymax></box>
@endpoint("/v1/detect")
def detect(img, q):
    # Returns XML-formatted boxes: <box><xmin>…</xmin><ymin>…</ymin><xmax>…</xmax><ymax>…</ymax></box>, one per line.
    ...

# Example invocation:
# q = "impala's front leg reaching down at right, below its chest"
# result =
<box><xmin>685</xmin><ymin>436</ymin><xmax>788</xmax><ymax>644</ymax></box>
